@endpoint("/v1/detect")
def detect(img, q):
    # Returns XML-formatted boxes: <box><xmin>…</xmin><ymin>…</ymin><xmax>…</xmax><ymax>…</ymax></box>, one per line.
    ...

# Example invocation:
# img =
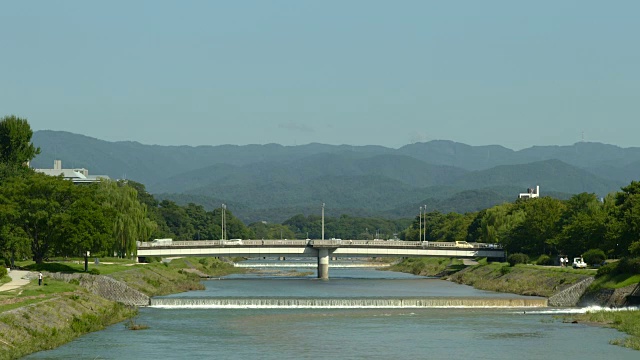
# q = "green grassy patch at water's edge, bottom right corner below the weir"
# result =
<box><xmin>565</xmin><ymin>310</ymin><xmax>640</xmax><ymax>350</ymax></box>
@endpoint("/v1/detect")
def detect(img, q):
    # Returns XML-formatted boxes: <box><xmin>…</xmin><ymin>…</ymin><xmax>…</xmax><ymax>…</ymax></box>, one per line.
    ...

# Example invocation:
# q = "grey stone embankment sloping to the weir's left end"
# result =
<box><xmin>46</xmin><ymin>273</ymin><xmax>149</xmax><ymax>306</ymax></box>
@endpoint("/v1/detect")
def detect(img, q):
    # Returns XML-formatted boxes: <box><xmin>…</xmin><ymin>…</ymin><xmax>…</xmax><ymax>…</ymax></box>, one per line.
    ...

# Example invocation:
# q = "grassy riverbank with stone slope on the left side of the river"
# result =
<box><xmin>0</xmin><ymin>258</ymin><xmax>242</xmax><ymax>359</ymax></box>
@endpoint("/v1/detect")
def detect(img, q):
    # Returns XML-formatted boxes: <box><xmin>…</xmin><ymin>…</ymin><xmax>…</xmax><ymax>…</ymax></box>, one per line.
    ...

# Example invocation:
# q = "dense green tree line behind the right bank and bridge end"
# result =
<box><xmin>401</xmin><ymin>181</ymin><xmax>640</xmax><ymax>258</ymax></box>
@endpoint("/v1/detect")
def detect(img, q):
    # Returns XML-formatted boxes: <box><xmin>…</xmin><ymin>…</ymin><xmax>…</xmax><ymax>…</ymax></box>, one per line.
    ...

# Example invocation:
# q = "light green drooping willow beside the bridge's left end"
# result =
<box><xmin>101</xmin><ymin>181</ymin><xmax>156</xmax><ymax>258</ymax></box>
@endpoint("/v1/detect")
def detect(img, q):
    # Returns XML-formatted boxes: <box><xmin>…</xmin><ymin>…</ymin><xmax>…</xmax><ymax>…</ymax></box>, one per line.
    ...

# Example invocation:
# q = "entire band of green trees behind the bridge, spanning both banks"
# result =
<box><xmin>0</xmin><ymin>116</ymin><xmax>640</xmax><ymax>263</ymax></box>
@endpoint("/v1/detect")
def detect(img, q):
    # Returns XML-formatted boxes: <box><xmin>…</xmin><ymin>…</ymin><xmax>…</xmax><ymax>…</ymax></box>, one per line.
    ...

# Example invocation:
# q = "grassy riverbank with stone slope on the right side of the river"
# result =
<box><xmin>392</xmin><ymin>258</ymin><xmax>640</xmax><ymax>350</ymax></box>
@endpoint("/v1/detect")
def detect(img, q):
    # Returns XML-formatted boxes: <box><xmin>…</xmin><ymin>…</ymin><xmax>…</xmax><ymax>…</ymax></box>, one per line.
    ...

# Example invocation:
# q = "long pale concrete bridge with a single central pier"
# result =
<box><xmin>138</xmin><ymin>239</ymin><xmax>505</xmax><ymax>279</ymax></box>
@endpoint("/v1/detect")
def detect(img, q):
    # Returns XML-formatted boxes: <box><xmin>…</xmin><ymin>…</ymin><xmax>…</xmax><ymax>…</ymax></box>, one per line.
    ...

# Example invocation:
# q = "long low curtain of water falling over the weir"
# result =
<box><xmin>150</xmin><ymin>297</ymin><xmax>547</xmax><ymax>309</ymax></box>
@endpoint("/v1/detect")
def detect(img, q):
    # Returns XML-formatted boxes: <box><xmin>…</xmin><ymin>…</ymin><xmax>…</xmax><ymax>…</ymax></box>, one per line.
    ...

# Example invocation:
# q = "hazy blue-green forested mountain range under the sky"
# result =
<box><xmin>31</xmin><ymin>130</ymin><xmax>640</xmax><ymax>222</ymax></box>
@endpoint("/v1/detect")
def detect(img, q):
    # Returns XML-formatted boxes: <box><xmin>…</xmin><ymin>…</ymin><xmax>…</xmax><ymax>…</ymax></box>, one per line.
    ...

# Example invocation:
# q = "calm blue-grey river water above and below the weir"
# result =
<box><xmin>26</xmin><ymin>269</ymin><xmax>640</xmax><ymax>360</ymax></box>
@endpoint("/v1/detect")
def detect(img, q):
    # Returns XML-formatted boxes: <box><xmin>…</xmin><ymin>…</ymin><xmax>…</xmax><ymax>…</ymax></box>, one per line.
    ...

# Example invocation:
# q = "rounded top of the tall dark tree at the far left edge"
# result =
<box><xmin>0</xmin><ymin>115</ymin><xmax>40</xmax><ymax>166</ymax></box>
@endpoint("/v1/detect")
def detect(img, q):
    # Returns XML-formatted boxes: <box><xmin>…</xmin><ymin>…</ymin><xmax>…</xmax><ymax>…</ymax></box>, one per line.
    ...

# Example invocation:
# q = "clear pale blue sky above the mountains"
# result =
<box><xmin>0</xmin><ymin>0</ymin><xmax>640</xmax><ymax>149</ymax></box>
